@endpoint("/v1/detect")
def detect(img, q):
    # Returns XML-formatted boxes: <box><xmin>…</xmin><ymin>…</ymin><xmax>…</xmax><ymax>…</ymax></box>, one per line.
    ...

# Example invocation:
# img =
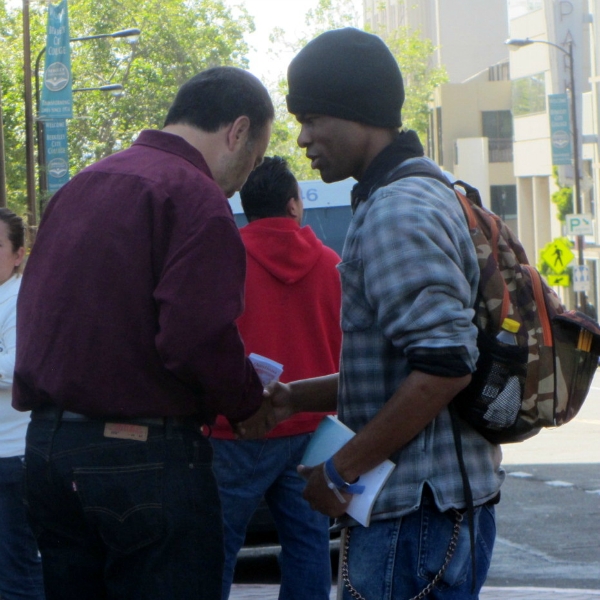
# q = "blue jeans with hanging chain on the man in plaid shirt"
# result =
<box><xmin>339</xmin><ymin>493</ymin><xmax>496</xmax><ymax>600</ymax></box>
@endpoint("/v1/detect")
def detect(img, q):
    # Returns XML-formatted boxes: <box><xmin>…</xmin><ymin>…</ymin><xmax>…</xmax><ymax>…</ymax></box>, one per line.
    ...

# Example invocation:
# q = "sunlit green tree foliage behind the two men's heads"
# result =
<box><xmin>0</xmin><ymin>0</ymin><xmax>445</xmax><ymax>215</ymax></box>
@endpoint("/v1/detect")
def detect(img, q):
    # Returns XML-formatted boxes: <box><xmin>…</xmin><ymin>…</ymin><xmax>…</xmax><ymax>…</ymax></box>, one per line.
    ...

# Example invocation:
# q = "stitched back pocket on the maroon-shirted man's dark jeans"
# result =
<box><xmin>73</xmin><ymin>463</ymin><xmax>165</xmax><ymax>554</ymax></box>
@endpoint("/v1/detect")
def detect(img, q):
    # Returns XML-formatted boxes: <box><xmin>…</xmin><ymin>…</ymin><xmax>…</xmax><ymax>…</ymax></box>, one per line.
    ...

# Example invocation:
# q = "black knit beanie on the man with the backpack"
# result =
<box><xmin>286</xmin><ymin>27</ymin><xmax>404</xmax><ymax>127</ymax></box>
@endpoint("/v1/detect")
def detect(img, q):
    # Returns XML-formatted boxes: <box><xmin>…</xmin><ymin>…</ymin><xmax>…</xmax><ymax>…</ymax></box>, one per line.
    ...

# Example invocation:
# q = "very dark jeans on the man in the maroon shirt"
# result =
<box><xmin>25</xmin><ymin>418</ymin><xmax>224</xmax><ymax>600</ymax></box>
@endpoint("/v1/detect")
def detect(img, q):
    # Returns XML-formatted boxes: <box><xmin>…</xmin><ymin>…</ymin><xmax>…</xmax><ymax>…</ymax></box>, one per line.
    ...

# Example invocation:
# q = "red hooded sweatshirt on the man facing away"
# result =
<box><xmin>212</xmin><ymin>217</ymin><xmax>342</xmax><ymax>439</ymax></box>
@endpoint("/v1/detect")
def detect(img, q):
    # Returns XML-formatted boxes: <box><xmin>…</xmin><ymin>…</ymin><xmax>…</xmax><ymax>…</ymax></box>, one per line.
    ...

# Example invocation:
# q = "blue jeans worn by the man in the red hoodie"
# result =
<box><xmin>211</xmin><ymin>434</ymin><xmax>331</xmax><ymax>600</ymax></box>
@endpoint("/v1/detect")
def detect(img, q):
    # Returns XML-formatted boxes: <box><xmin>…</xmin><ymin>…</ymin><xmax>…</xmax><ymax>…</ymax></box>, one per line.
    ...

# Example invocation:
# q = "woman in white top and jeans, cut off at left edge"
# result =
<box><xmin>0</xmin><ymin>208</ymin><xmax>44</xmax><ymax>600</ymax></box>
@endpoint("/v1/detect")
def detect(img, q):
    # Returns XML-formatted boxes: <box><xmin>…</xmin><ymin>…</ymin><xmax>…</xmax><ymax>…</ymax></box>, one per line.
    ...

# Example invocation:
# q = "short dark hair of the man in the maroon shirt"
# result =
<box><xmin>165</xmin><ymin>67</ymin><xmax>275</xmax><ymax>139</ymax></box>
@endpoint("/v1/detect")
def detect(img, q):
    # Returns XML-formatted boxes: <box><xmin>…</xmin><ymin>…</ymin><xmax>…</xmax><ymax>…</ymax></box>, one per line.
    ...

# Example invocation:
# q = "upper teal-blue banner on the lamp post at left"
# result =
<box><xmin>38</xmin><ymin>0</ymin><xmax>73</xmax><ymax>120</ymax></box>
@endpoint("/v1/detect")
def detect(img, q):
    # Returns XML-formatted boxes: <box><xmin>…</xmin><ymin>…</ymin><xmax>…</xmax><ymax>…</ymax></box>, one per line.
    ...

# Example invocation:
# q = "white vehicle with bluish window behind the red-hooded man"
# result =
<box><xmin>229</xmin><ymin>179</ymin><xmax>356</xmax><ymax>255</ymax></box>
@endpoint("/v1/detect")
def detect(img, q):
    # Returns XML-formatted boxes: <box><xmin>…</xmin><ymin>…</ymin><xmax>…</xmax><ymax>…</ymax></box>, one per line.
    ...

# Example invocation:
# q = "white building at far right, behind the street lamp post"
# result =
<box><xmin>510</xmin><ymin>0</ymin><xmax>599</xmax><ymax>306</ymax></box>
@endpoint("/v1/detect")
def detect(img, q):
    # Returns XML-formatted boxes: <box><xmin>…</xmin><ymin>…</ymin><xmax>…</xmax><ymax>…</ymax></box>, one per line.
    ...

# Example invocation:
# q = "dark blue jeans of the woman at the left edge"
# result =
<box><xmin>0</xmin><ymin>456</ymin><xmax>44</xmax><ymax>600</ymax></box>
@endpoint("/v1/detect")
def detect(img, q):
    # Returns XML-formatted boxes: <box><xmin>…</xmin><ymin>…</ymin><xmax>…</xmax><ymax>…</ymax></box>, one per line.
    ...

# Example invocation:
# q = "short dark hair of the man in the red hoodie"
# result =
<box><xmin>240</xmin><ymin>156</ymin><xmax>298</xmax><ymax>221</ymax></box>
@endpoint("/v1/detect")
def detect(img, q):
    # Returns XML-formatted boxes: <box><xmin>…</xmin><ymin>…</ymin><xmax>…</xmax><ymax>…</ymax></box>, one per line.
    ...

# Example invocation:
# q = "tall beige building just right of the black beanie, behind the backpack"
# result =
<box><xmin>363</xmin><ymin>0</ymin><xmax>517</xmax><ymax>228</ymax></box>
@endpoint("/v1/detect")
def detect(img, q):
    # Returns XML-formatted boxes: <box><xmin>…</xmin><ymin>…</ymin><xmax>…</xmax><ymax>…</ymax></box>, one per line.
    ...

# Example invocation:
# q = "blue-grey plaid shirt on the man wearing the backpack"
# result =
<box><xmin>338</xmin><ymin>158</ymin><xmax>504</xmax><ymax>520</ymax></box>
